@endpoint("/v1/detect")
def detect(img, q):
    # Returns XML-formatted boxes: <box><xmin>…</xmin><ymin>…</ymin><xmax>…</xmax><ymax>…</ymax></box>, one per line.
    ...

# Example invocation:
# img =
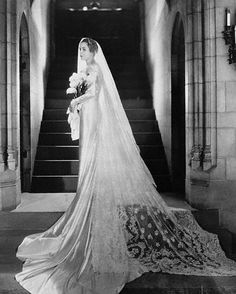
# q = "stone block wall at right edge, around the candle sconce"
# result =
<box><xmin>215</xmin><ymin>0</ymin><xmax>236</xmax><ymax>232</ymax></box>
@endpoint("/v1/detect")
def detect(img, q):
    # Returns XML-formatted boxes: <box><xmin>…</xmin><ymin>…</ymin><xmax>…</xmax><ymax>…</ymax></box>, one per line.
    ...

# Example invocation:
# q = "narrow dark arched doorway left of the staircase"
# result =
<box><xmin>19</xmin><ymin>13</ymin><xmax>31</xmax><ymax>192</ymax></box>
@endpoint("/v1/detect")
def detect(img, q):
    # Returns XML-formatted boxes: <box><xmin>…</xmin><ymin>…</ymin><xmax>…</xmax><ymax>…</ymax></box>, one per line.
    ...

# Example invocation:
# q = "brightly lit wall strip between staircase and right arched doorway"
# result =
<box><xmin>144</xmin><ymin>0</ymin><xmax>185</xmax><ymax>181</ymax></box>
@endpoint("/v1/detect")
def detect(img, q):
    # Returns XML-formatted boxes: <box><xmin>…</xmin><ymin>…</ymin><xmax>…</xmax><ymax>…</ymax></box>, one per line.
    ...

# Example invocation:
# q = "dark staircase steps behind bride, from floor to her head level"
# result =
<box><xmin>32</xmin><ymin>54</ymin><xmax>170</xmax><ymax>192</ymax></box>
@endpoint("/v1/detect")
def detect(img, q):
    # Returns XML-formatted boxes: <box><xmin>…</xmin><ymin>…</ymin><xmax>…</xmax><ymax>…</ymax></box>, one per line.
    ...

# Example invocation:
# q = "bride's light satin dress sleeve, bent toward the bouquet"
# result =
<box><xmin>75</xmin><ymin>69</ymin><xmax>98</xmax><ymax>104</ymax></box>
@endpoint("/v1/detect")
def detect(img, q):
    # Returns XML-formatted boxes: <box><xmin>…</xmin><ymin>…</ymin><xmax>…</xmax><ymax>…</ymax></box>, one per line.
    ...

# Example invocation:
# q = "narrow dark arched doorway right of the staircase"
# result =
<box><xmin>171</xmin><ymin>13</ymin><xmax>186</xmax><ymax>195</ymax></box>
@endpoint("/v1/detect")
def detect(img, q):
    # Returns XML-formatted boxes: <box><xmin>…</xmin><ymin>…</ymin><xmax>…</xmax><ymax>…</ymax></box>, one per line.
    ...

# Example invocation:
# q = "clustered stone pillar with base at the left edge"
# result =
<box><xmin>0</xmin><ymin>0</ymin><xmax>18</xmax><ymax>210</ymax></box>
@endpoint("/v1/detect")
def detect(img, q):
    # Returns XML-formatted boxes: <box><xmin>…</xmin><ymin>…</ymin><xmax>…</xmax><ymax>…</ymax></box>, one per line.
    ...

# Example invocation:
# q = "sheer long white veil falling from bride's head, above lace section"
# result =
<box><xmin>78</xmin><ymin>39</ymin><xmax>161</xmax><ymax>284</ymax></box>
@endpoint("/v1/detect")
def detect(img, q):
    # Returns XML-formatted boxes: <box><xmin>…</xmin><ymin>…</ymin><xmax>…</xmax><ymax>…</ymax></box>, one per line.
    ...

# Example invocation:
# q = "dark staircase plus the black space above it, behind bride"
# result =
<box><xmin>31</xmin><ymin>0</ymin><xmax>171</xmax><ymax>193</ymax></box>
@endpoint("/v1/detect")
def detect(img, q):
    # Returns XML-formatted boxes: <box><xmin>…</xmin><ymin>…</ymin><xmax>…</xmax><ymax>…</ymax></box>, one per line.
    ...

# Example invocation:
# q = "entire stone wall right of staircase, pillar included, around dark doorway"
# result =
<box><xmin>145</xmin><ymin>0</ymin><xmax>236</xmax><ymax>232</ymax></box>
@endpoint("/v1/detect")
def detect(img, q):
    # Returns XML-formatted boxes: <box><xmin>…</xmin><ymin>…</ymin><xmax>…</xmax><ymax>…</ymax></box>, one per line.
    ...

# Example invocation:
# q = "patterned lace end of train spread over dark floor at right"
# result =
<box><xmin>119</xmin><ymin>205</ymin><xmax>235</xmax><ymax>275</ymax></box>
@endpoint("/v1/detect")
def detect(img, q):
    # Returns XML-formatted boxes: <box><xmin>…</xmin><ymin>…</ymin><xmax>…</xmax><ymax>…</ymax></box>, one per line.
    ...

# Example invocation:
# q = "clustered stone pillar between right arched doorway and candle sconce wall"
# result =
<box><xmin>187</xmin><ymin>0</ymin><xmax>217</xmax><ymax>171</ymax></box>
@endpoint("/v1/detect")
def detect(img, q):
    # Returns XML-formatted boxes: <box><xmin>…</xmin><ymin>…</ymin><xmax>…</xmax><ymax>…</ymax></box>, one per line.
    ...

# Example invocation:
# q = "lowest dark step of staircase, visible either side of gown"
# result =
<box><xmin>31</xmin><ymin>174</ymin><xmax>171</xmax><ymax>193</ymax></box>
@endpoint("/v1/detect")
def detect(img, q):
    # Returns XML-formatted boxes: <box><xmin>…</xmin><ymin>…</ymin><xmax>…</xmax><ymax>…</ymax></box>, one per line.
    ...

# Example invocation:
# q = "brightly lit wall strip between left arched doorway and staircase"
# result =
<box><xmin>22</xmin><ymin>0</ymin><xmax>51</xmax><ymax>184</ymax></box>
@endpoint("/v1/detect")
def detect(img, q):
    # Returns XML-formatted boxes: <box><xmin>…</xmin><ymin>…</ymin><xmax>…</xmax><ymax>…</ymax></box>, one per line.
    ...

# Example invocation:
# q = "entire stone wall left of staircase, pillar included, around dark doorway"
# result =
<box><xmin>0</xmin><ymin>0</ymin><xmax>50</xmax><ymax>210</ymax></box>
